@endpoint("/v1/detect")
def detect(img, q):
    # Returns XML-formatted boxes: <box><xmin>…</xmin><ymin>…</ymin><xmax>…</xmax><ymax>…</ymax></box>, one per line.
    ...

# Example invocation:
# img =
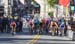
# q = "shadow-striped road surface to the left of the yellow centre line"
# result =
<box><xmin>0</xmin><ymin>35</ymin><xmax>35</xmax><ymax>44</ymax></box>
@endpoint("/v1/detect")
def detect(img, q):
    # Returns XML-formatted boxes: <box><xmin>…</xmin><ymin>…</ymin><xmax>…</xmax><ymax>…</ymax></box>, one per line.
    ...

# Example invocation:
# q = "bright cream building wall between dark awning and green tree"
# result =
<box><xmin>35</xmin><ymin>0</ymin><xmax>49</xmax><ymax>18</ymax></box>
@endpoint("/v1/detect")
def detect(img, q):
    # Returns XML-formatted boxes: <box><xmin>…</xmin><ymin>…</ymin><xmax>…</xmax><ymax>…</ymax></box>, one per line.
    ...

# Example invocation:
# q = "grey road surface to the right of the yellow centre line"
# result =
<box><xmin>36</xmin><ymin>35</ymin><xmax>75</xmax><ymax>44</ymax></box>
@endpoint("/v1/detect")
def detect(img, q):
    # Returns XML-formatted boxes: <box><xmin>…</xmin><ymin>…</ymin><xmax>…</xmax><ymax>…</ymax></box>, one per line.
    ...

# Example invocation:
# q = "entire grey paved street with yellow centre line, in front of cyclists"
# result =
<box><xmin>0</xmin><ymin>29</ymin><xmax>75</xmax><ymax>44</ymax></box>
